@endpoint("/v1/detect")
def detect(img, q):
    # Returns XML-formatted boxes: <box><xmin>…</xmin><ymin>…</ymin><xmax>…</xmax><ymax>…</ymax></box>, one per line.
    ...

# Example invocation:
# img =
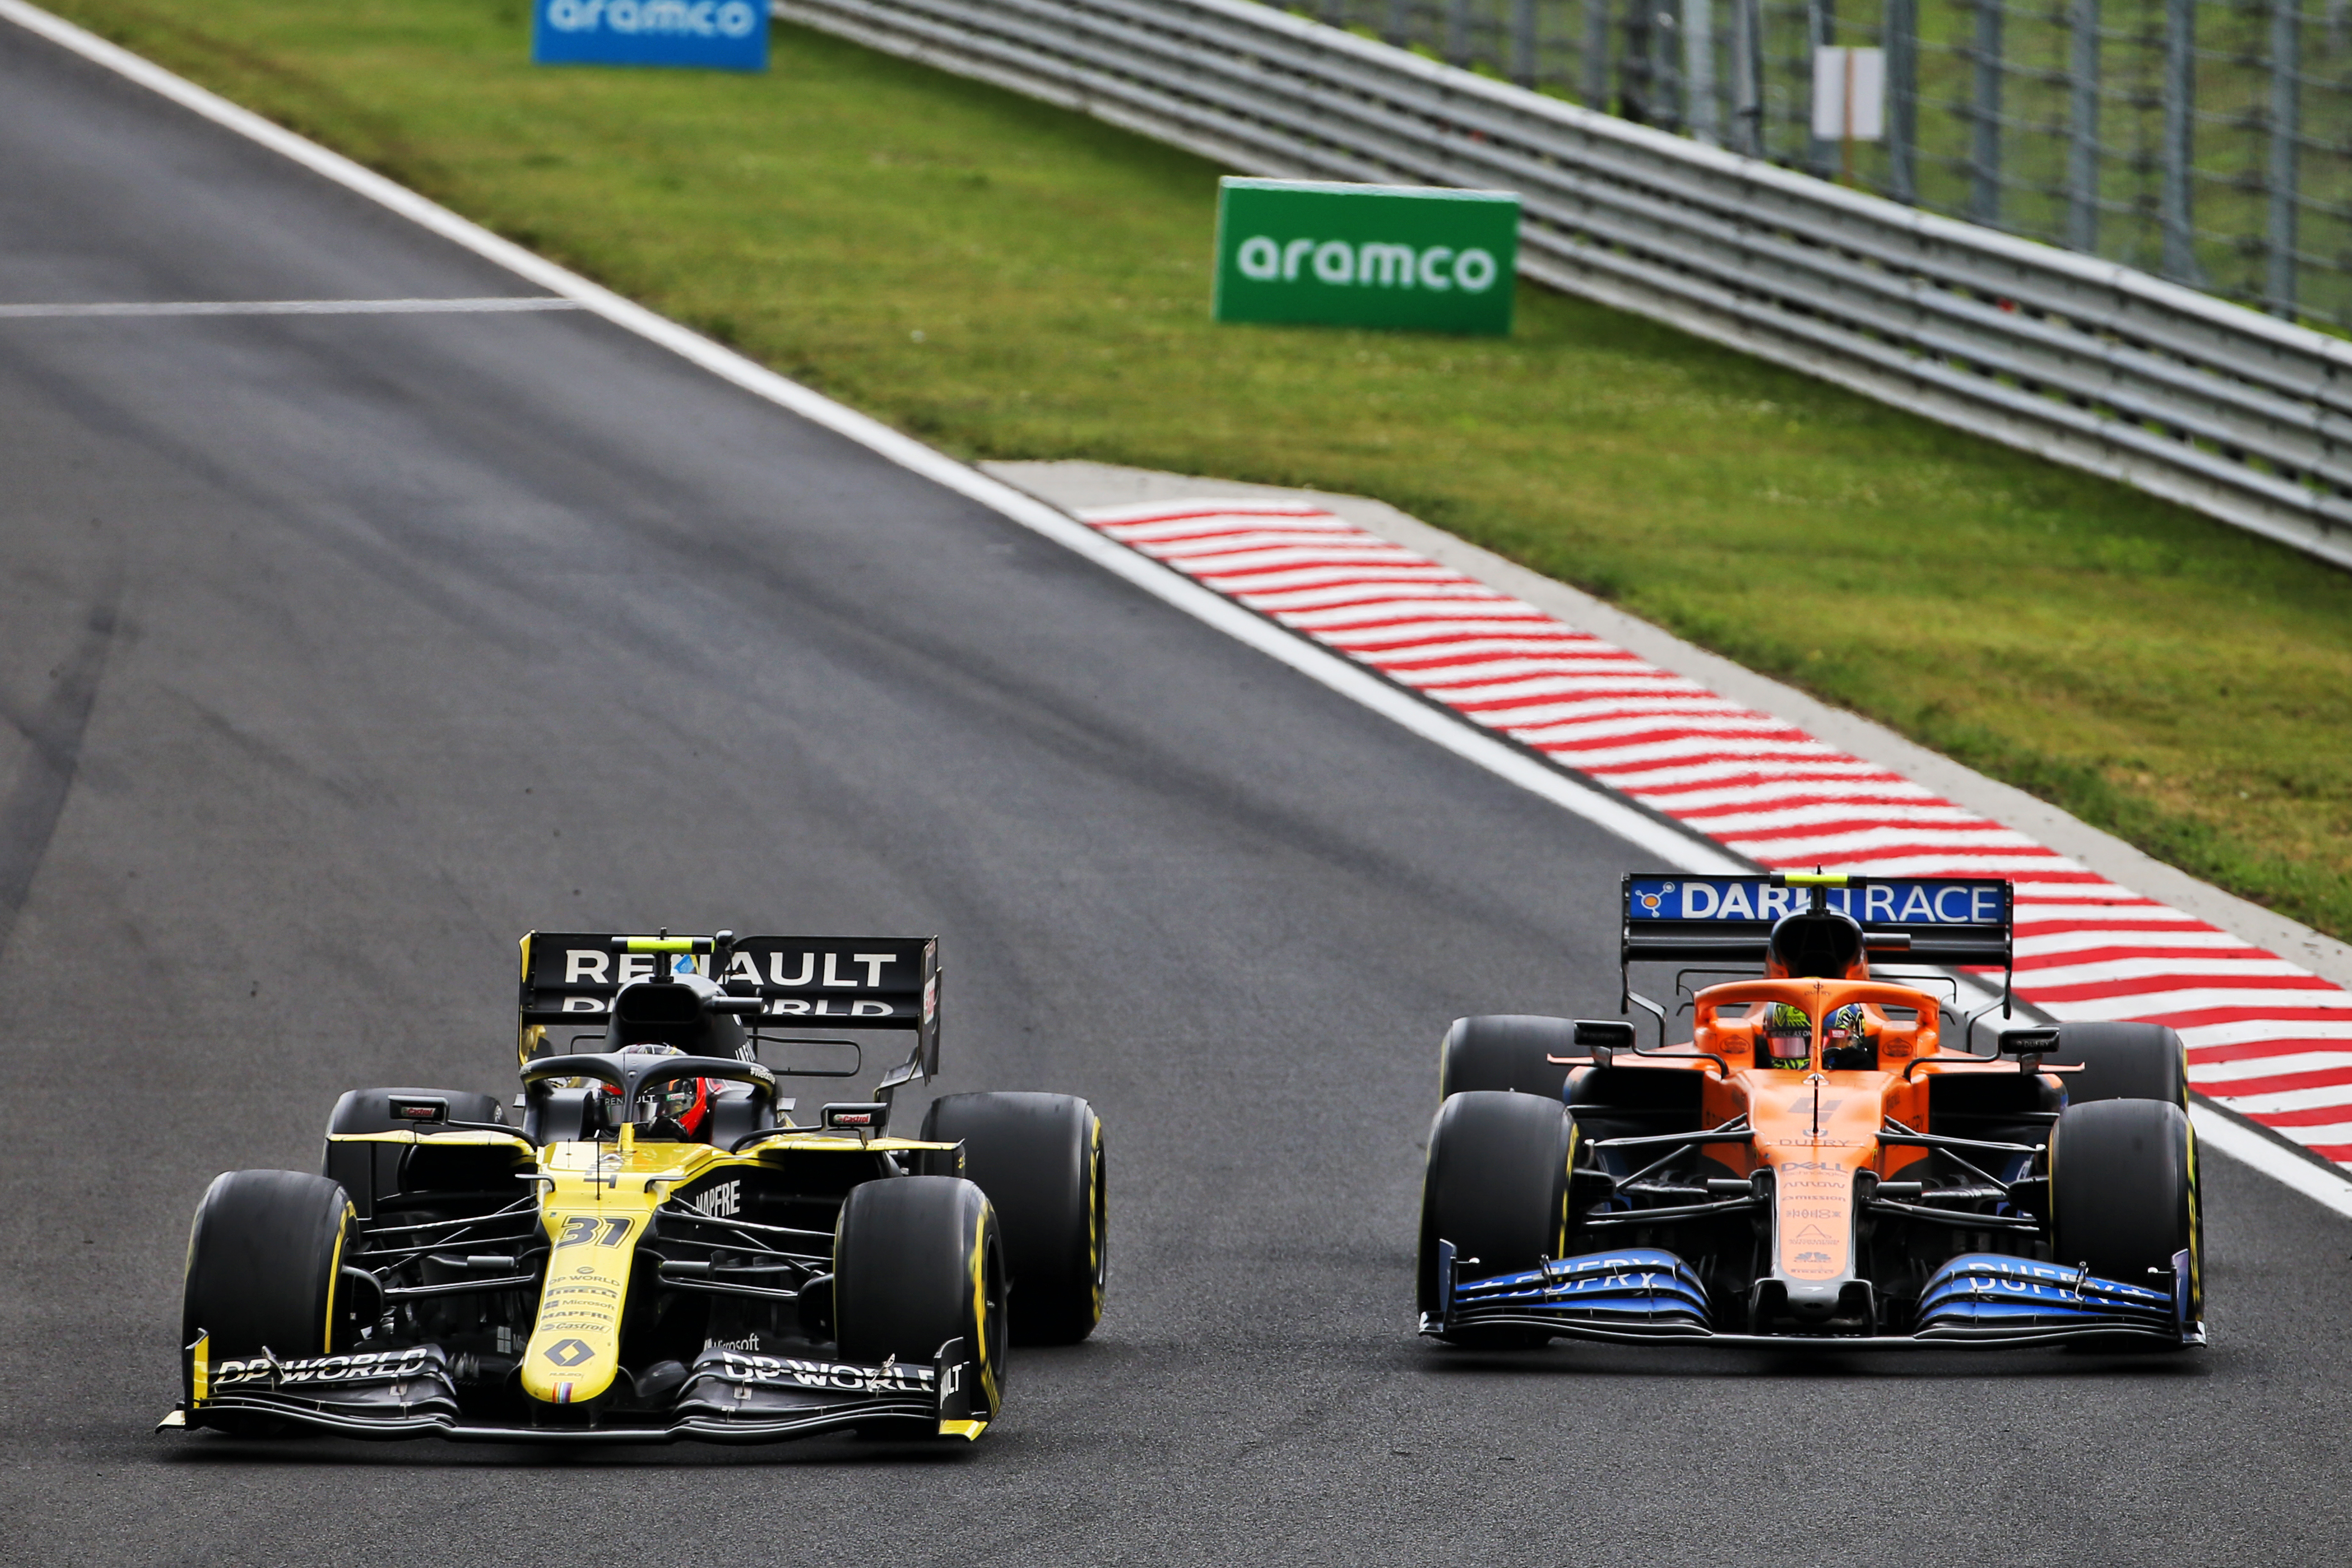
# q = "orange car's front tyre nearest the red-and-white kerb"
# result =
<box><xmin>2051</xmin><ymin>1100</ymin><xmax>2204</xmax><ymax>1321</ymax></box>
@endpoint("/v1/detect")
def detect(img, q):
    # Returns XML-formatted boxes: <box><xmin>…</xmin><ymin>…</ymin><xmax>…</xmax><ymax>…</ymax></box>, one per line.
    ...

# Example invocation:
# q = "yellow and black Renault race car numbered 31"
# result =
<box><xmin>165</xmin><ymin>931</ymin><xmax>1105</xmax><ymax>1443</ymax></box>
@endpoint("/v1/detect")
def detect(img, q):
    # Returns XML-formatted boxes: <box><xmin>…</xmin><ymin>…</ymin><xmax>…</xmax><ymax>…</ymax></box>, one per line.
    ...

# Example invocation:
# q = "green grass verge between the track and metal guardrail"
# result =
<box><xmin>46</xmin><ymin>0</ymin><xmax>2352</xmax><ymax>933</ymax></box>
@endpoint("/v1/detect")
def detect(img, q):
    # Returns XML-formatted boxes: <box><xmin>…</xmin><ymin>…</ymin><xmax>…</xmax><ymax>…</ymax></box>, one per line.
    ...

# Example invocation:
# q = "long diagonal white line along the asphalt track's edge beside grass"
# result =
<box><xmin>23</xmin><ymin>0</ymin><xmax>2352</xmax><ymax>1218</ymax></box>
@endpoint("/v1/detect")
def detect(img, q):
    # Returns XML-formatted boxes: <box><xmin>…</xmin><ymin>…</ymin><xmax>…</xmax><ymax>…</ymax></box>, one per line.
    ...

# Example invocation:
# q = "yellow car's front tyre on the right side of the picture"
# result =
<box><xmin>833</xmin><ymin>1176</ymin><xmax>1004</xmax><ymax>1420</ymax></box>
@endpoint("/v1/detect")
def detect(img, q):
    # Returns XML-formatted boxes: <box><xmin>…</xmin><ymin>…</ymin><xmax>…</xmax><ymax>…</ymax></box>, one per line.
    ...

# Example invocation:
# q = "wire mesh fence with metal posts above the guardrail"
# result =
<box><xmin>1289</xmin><ymin>0</ymin><xmax>2352</xmax><ymax>332</ymax></box>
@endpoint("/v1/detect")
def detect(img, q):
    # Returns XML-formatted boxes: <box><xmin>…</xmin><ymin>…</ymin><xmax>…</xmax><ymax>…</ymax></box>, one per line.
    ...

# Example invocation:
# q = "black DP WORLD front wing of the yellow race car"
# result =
<box><xmin>162</xmin><ymin>1340</ymin><xmax>990</xmax><ymax>1443</ymax></box>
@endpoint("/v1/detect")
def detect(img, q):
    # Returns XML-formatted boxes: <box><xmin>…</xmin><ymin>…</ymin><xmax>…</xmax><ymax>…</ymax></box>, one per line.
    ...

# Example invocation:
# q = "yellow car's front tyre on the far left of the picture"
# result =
<box><xmin>179</xmin><ymin>1171</ymin><xmax>350</xmax><ymax>1436</ymax></box>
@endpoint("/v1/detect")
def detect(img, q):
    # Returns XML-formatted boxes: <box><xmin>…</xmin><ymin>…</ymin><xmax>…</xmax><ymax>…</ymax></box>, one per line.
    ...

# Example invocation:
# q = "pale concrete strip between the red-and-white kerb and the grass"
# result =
<box><xmin>981</xmin><ymin>461</ymin><xmax>2352</xmax><ymax>987</ymax></box>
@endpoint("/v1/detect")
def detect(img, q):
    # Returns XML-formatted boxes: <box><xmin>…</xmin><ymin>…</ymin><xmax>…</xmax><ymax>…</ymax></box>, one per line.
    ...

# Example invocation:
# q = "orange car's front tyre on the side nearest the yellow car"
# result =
<box><xmin>1418</xmin><ymin>1088</ymin><xmax>1576</xmax><ymax>1347</ymax></box>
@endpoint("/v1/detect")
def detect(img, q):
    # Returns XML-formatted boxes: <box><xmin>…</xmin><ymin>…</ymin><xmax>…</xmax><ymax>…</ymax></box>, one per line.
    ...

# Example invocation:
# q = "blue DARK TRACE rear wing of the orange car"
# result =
<box><xmin>1621</xmin><ymin>872</ymin><xmax>2014</xmax><ymax>969</ymax></box>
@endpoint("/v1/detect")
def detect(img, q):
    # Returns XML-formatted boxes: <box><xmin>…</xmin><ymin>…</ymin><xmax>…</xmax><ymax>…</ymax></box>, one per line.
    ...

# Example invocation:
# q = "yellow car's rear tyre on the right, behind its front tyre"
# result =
<box><xmin>922</xmin><ymin>1093</ymin><xmax>1110</xmax><ymax>1345</ymax></box>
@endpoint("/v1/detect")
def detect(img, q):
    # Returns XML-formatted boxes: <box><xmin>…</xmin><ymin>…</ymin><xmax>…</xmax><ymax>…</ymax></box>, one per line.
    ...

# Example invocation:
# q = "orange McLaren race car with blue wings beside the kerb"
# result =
<box><xmin>1418</xmin><ymin>874</ymin><xmax>2204</xmax><ymax>1349</ymax></box>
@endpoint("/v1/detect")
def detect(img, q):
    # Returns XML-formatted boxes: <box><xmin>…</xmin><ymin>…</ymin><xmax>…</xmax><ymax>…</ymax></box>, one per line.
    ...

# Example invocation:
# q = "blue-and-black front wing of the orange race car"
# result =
<box><xmin>1421</xmin><ymin>1241</ymin><xmax>2204</xmax><ymax>1349</ymax></box>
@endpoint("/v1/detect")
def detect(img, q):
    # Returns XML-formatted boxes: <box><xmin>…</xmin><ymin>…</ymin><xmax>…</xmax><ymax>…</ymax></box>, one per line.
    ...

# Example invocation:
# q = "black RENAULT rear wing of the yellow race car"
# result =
<box><xmin>517</xmin><ymin>931</ymin><xmax>938</xmax><ymax>1077</ymax></box>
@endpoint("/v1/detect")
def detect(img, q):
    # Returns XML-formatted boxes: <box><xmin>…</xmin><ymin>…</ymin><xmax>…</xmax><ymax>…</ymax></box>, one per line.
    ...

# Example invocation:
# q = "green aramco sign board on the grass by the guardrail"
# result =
<box><xmin>1216</xmin><ymin>179</ymin><xmax>1519</xmax><ymax>332</ymax></box>
